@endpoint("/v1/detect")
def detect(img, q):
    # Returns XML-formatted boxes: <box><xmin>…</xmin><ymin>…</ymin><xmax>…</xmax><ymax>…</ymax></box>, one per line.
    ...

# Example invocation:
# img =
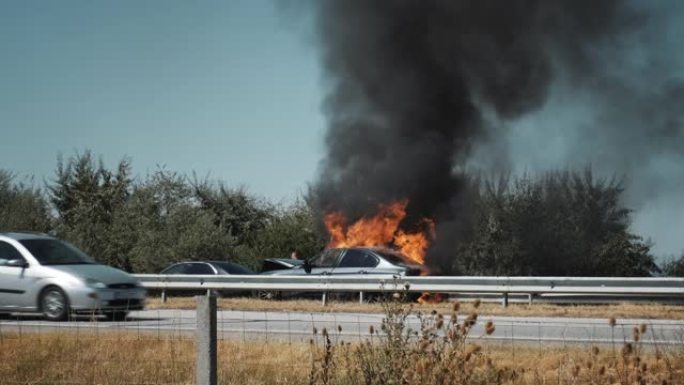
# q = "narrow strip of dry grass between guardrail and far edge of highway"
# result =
<box><xmin>147</xmin><ymin>297</ymin><xmax>684</xmax><ymax>319</ymax></box>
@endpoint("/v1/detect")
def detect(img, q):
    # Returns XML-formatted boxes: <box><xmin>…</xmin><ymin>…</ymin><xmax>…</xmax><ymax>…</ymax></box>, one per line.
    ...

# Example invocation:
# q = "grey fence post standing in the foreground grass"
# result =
<box><xmin>195</xmin><ymin>293</ymin><xmax>217</xmax><ymax>385</ymax></box>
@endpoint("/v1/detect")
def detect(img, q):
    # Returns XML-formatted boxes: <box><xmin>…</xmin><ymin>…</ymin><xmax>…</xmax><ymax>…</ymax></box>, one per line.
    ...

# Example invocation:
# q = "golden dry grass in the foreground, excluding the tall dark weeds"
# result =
<box><xmin>0</xmin><ymin>324</ymin><xmax>684</xmax><ymax>385</ymax></box>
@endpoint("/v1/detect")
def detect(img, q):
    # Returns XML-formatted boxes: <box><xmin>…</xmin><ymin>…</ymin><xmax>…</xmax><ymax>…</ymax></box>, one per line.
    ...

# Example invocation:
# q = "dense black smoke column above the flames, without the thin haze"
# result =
<box><xmin>314</xmin><ymin>0</ymin><xmax>684</xmax><ymax>261</ymax></box>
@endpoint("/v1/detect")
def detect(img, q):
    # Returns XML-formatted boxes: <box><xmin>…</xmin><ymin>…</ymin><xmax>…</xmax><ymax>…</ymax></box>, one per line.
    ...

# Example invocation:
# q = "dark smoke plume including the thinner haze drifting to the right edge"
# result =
<box><xmin>313</xmin><ymin>0</ymin><xmax>684</xmax><ymax>266</ymax></box>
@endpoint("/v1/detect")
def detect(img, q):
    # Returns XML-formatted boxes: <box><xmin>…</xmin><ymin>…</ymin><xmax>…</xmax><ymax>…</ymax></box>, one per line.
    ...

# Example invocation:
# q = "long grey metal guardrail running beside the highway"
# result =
<box><xmin>135</xmin><ymin>274</ymin><xmax>684</xmax><ymax>297</ymax></box>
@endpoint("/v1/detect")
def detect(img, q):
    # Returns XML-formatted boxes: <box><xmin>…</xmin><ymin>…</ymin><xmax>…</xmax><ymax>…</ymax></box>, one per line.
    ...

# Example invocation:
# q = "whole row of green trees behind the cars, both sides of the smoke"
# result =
<box><xmin>0</xmin><ymin>151</ymin><xmax>684</xmax><ymax>276</ymax></box>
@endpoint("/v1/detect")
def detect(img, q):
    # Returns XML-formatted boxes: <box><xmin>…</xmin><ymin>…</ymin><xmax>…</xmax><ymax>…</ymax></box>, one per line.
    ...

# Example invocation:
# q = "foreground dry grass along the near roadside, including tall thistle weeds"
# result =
<box><xmin>0</xmin><ymin>302</ymin><xmax>684</xmax><ymax>385</ymax></box>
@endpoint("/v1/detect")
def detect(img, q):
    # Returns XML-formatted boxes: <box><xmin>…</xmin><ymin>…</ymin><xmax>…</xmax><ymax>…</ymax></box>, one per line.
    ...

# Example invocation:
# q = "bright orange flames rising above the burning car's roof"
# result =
<box><xmin>324</xmin><ymin>200</ymin><xmax>435</xmax><ymax>264</ymax></box>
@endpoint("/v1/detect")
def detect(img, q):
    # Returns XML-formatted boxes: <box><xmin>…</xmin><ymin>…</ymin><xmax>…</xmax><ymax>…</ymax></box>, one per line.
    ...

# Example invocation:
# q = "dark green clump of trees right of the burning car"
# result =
<box><xmin>452</xmin><ymin>169</ymin><xmax>657</xmax><ymax>276</ymax></box>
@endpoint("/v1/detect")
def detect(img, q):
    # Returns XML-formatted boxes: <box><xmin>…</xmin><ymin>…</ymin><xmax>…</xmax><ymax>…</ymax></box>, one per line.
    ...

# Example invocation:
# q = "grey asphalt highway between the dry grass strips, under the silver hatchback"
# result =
<box><xmin>0</xmin><ymin>309</ymin><xmax>684</xmax><ymax>346</ymax></box>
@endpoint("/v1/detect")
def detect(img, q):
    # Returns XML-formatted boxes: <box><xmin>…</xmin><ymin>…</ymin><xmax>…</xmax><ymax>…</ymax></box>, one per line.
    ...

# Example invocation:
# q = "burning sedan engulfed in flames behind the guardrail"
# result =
<box><xmin>259</xmin><ymin>247</ymin><xmax>427</xmax><ymax>299</ymax></box>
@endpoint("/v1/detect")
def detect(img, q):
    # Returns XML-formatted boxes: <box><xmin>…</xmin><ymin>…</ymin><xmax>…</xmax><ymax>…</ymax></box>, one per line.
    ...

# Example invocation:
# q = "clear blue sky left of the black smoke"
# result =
<box><xmin>0</xmin><ymin>0</ymin><xmax>324</xmax><ymax>201</ymax></box>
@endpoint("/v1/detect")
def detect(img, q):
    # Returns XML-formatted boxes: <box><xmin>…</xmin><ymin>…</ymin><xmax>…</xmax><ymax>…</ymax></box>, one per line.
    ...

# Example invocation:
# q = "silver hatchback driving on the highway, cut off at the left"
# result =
<box><xmin>0</xmin><ymin>232</ymin><xmax>145</xmax><ymax>321</ymax></box>
